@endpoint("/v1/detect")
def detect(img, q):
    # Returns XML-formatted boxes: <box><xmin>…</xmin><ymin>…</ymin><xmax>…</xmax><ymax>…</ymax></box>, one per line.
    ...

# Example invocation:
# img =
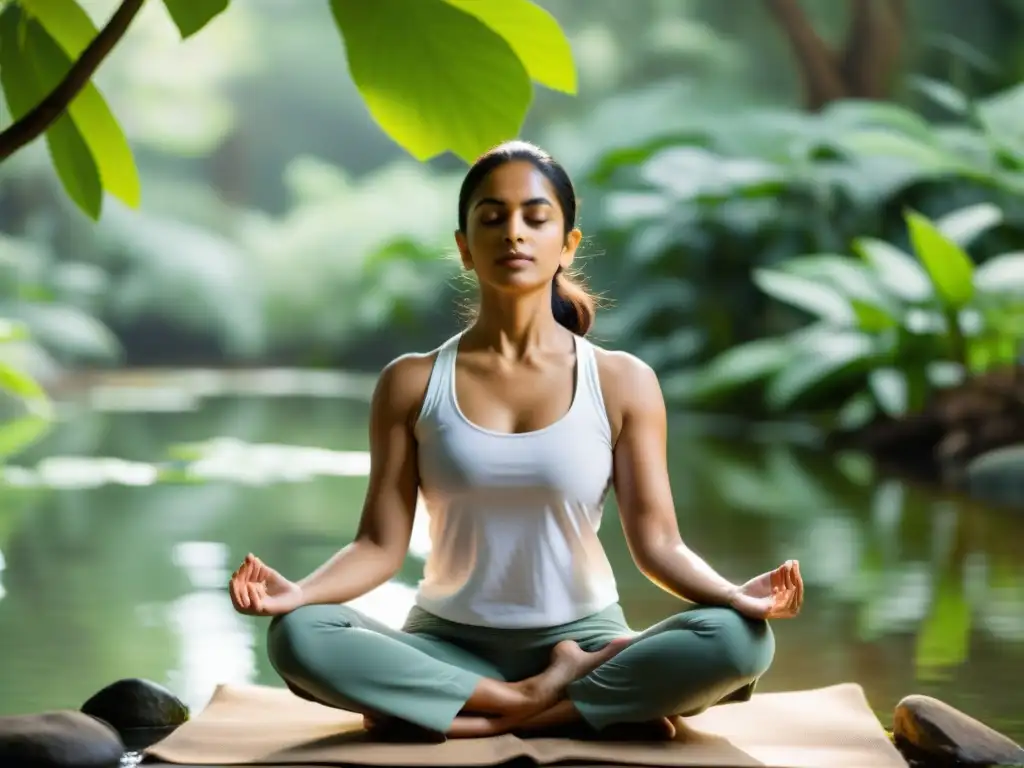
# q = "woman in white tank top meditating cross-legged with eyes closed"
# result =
<box><xmin>229</xmin><ymin>141</ymin><xmax>803</xmax><ymax>737</ymax></box>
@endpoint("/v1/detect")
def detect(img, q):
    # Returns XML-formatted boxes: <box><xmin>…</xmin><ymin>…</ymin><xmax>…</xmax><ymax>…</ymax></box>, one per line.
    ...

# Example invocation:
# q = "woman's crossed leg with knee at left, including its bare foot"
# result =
<box><xmin>267</xmin><ymin>605</ymin><xmax>622</xmax><ymax>736</ymax></box>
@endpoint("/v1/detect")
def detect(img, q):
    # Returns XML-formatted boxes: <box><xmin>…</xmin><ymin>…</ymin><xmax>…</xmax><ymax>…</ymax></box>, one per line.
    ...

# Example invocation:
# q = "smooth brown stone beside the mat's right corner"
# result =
<box><xmin>893</xmin><ymin>694</ymin><xmax>1024</xmax><ymax>768</ymax></box>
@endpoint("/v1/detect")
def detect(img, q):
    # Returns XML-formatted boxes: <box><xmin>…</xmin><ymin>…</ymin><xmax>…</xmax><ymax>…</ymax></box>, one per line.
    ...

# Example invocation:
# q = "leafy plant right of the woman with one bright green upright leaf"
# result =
<box><xmin>688</xmin><ymin>204</ymin><xmax>1024</xmax><ymax>421</ymax></box>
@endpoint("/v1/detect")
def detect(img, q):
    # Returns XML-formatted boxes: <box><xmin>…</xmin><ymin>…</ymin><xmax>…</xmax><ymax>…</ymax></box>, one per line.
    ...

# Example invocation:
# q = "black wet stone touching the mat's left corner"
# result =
<box><xmin>82</xmin><ymin>678</ymin><xmax>188</xmax><ymax>736</ymax></box>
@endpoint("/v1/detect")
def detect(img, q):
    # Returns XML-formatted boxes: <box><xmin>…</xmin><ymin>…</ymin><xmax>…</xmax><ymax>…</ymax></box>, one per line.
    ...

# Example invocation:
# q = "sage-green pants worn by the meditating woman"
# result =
<box><xmin>267</xmin><ymin>605</ymin><xmax>775</xmax><ymax>732</ymax></box>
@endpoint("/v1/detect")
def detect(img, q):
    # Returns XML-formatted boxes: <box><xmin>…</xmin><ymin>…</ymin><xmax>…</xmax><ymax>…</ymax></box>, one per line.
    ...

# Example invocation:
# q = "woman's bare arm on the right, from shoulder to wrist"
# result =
<box><xmin>601</xmin><ymin>352</ymin><xmax>738</xmax><ymax>605</ymax></box>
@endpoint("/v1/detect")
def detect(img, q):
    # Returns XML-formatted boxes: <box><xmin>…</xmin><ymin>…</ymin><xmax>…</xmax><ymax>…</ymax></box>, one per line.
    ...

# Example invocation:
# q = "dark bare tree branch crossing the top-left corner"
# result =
<box><xmin>0</xmin><ymin>0</ymin><xmax>145</xmax><ymax>163</ymax></box>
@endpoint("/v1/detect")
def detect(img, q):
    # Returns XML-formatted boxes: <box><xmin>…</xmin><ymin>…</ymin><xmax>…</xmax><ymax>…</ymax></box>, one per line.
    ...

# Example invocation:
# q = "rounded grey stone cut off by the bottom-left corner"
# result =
<box><xmin>0</xmin><ymin>711</ymin><xmax>125</xmax><ymax>768</ymax></box>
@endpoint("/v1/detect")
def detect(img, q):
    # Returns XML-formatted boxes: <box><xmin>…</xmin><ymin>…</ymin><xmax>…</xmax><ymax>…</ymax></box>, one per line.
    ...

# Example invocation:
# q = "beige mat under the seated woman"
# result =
<box><xmin>146</xmin><ymin>683</ymin><xmax>906</xmax><ymax>768</ymax></box>
